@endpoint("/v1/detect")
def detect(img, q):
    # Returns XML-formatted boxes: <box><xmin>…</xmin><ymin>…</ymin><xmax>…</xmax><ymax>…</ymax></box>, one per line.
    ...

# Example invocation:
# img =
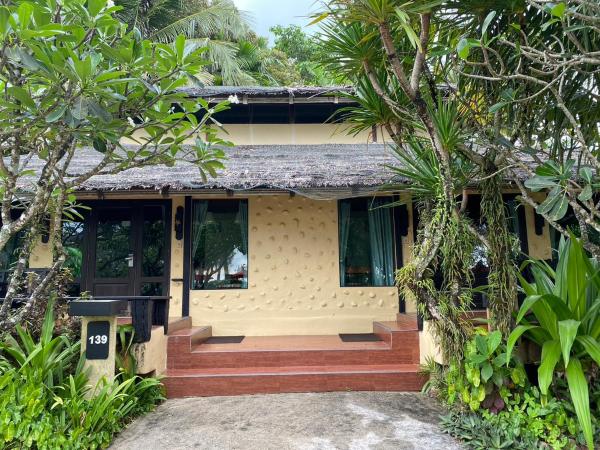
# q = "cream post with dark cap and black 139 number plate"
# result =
<box><xmin>69</xmin><ymin>299</ymin><xmax>127</xmax><ymax>392</ymax></box>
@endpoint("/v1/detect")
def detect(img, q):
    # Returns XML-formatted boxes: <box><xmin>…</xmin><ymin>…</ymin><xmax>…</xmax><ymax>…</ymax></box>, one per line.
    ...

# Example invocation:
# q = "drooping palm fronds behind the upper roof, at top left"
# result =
<box><xmin>115</xmin><ymin>0</ymin><xmax>256</xmax><ymax>85</ymax></box>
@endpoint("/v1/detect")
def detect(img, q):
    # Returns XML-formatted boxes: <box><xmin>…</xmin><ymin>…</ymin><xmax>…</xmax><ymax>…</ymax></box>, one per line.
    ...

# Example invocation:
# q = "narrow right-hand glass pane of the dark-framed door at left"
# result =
<box><xmin>142</xmin><ymin>206</ymin><xmax>166</xmax><ymax>277</ymax></box>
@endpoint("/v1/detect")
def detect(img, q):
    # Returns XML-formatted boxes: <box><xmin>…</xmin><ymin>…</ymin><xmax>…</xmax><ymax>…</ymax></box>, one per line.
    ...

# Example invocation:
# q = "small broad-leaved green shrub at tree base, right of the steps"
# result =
<box><xmin>443</xmin><ymin>330</ymin><xmax>527</xmax><ymax>413</ymax></box>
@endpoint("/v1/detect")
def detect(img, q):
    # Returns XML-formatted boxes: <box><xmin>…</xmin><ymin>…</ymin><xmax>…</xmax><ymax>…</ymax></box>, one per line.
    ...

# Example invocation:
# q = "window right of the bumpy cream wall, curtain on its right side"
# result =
<box><xmin>339</xmin><ymin>197</ymin><xmax>396</xmax><ymax>286</ymax></box>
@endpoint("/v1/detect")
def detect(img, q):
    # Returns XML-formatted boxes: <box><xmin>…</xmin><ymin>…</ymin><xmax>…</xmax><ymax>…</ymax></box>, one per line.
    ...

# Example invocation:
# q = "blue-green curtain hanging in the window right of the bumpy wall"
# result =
<box><xmin>369</xmin><ymin>198</ymin><xmax>394</xmax><ymax>286</ymax></box>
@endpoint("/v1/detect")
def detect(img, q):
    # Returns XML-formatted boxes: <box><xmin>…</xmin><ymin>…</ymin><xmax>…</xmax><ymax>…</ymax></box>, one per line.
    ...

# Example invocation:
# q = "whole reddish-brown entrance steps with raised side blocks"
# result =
<box><xmin>164</xmin><ymin>314</ymin><xmax>424</xmax><ymax>398</ymax></box>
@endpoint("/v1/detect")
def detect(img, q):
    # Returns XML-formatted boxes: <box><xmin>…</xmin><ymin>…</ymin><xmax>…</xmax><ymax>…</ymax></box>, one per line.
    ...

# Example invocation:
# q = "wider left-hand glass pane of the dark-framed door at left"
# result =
<box><xmin>96</xmin><ymin>208</ymin><xmax>131</xmax><ymax>278</ymax></box>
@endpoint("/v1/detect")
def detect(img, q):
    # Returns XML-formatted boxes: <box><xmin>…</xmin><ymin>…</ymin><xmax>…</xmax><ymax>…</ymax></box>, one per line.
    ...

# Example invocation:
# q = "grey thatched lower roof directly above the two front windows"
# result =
<box><xmin>15</xmin><ymin>144</ymin><xmax>397</xmax><ymax>192</ymax></box>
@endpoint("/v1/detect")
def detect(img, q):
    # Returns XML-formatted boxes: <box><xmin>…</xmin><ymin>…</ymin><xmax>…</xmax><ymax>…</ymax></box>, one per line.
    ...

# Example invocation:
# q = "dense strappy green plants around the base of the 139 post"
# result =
<box><xmin>0</xmin><ymin>305</ymin><xmax>162</xmax><ymax>450</ymax></box>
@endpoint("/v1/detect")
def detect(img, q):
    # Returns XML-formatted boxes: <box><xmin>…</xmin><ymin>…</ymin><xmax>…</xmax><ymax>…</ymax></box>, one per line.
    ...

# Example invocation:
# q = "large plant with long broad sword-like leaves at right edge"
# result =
<box><xmin>507</xmin><ymin>235</ymin><xmax>600</xmax><ymax>448</ymax></box>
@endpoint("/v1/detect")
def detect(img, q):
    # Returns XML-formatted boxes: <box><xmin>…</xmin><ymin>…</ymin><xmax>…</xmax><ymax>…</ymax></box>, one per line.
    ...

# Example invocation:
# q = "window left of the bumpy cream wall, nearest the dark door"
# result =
<box><xmin>191</xmin><ymin>200</ymin><xmax>248</xmax><ymax>289</ymax></box>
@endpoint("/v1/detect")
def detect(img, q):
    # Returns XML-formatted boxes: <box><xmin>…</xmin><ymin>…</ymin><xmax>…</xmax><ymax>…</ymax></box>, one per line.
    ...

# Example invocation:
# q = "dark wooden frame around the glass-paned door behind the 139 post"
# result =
<box><xmin>81</xmin><ymin>199</ymin><xmax>173</xmax><ymax>296</ymax></box>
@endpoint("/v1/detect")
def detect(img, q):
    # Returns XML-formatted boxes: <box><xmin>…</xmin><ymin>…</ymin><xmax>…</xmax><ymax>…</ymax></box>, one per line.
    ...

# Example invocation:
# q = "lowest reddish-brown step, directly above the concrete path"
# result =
<box><xmin>163</xmin><ymin>364</ymin><xmax>424</xmax><ymax>398</ymax></box>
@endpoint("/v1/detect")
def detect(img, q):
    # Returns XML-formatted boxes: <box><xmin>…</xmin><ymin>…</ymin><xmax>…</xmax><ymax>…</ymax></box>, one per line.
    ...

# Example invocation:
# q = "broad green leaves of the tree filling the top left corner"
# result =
<box><xmin>0</xmin><ymin>0</ymin><xmax>223</xmax><ymax>158</ymax></box>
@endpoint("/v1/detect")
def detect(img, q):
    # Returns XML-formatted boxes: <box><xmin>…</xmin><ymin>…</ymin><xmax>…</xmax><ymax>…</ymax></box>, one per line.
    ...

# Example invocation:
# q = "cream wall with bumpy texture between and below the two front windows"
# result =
<box><xmin>190</xmin><ymin>195</ymin><xmax>398</xmax><ymax>336</ymax></box>
